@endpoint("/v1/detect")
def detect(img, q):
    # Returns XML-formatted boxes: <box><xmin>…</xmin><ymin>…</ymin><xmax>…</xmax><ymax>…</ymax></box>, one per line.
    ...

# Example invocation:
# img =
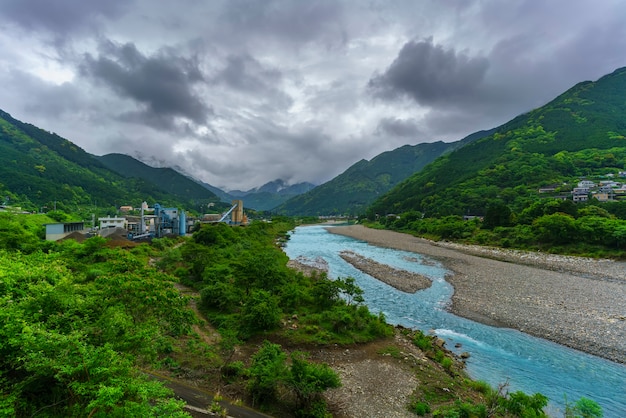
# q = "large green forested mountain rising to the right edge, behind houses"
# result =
<box><xmin>368</xmin><ymin>68</ymin><xmax>626</xmax><ymax>217</ymax></box>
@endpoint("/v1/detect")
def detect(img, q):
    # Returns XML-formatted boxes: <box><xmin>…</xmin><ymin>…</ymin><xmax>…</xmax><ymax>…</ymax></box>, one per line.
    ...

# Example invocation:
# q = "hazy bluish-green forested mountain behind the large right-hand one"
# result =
<box><xmin>275</xmin><ymin>130</ymin><xmax>493</xmax><ymax>216</ymax></box>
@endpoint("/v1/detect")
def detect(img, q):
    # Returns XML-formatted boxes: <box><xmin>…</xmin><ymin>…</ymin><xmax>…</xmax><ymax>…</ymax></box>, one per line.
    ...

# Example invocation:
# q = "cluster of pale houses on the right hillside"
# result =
<box><xmin>539</xmin><ymin>171</ymin><xmax>626</xmax><ymax>203</ymax></box>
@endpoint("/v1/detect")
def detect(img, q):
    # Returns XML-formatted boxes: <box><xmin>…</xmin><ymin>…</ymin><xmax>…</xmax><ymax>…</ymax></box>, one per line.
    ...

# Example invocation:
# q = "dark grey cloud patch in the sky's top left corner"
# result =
<box><xmin>0</xmin><ymin>0</ymin><xmax>132</xmax><ymax>35</ymax></box>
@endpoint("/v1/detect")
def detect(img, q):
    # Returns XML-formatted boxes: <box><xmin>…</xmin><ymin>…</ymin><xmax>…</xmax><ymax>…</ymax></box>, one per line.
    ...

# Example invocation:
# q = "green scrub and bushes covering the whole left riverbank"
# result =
<box><xmin>0</xmin><ymin>214</ymin><xmax>604</xmax><ymax>417</ymax></box>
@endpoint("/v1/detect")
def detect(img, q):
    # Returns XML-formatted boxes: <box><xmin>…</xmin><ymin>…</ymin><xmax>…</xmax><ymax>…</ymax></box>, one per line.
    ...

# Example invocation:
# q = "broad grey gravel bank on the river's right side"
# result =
<box><xmin>328</xmin><ymin>225</ymin><xmax>626</xmax><ymax>363</ymax></box>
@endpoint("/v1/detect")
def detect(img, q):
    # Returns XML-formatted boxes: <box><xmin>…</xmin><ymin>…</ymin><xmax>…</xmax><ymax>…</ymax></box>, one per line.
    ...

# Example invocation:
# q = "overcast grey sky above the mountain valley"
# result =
<box><xmin>0</xmin><ymin>0</ymin><xmax>626</xmax><ymax>190</ymax></box>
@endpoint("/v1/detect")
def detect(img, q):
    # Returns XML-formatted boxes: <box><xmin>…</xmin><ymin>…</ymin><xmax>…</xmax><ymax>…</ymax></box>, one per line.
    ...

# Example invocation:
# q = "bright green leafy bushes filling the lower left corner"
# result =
<box><xmin>0</xmin><ymin>219</ymin><xmax>193</xmax><ymax>417</ymax></box>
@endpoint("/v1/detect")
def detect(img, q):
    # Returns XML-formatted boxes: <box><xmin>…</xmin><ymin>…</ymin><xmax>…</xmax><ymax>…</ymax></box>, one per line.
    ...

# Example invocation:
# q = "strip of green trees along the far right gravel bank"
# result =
<box><xmin>364</xmin><ymin>198</ymin><xmax>626</xmax><ymax>259</ymax></box>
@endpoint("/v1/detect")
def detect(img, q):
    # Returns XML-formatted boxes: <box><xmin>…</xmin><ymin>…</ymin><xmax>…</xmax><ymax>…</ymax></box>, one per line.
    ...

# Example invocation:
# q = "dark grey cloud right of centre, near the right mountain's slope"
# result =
<box><xmin>368</xmin><ymin>38</ymin><xmax>489</xmax><ymax>105</ymax></box>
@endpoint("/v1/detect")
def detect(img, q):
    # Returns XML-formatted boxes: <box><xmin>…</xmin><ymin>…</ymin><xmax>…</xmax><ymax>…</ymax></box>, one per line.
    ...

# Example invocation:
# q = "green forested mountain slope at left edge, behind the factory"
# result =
<box><xmin>0</xmin><ymin>111</ymin><xmax>217</xmax><ymax>212</ymax></box>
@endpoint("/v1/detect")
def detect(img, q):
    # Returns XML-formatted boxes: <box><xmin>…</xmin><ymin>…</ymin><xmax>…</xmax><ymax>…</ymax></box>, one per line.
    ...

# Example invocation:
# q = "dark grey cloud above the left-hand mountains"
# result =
<box><xmin>81</xmin><ymin>42</ymin><xmax>212</xmax><ymax>126</ymax></box>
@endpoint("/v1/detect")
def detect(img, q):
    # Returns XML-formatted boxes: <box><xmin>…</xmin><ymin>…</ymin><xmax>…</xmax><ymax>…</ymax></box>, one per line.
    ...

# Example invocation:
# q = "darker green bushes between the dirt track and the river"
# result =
<box><xmin>166</xmin><ymin>221</ymin><xmax>391</xmax><ymax>344</ymax></box>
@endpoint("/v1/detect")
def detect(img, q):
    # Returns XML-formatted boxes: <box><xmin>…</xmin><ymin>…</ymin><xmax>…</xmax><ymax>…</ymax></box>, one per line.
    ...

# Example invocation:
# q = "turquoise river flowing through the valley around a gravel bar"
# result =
<box><xmin>284</xmin><ymin>225</ymin><xmax>626</xmax><ymax>418</ymax></box>
